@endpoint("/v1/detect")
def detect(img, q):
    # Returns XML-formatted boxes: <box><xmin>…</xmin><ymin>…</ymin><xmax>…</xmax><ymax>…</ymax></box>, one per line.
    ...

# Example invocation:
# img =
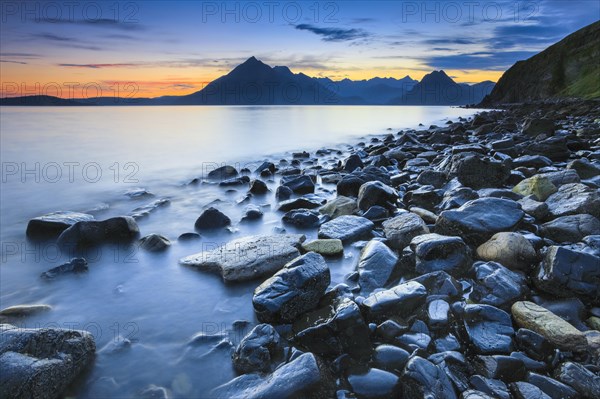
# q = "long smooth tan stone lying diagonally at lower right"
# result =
<box><xmin>511</xmin><ymin>301</ymin><xmax>588</xmax><ymax>352</ymax></box>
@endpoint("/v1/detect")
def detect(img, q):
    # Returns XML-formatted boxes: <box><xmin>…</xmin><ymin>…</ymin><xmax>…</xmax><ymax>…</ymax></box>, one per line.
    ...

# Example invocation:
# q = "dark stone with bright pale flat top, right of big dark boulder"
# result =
<box><xmin>362</xmin><ymin>281</ymin><xmax>427</xmax><ymax>321</ymax></box>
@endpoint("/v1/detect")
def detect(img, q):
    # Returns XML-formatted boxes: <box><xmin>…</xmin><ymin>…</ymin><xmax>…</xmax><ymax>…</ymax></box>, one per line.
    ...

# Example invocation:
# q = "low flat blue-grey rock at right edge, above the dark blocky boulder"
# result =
<box><xmin>540</xmin><ymin>214</ymin><xmax>600</xmax><ymax>242</ymax></box>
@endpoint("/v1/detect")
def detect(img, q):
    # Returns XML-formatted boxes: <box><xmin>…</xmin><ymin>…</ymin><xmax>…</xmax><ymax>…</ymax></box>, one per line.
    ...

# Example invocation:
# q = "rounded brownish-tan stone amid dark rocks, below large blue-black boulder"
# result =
<box><xmin>477</xmin><ymin>232</ymin><xmax>537</xmax><ymax>270</ymax></box>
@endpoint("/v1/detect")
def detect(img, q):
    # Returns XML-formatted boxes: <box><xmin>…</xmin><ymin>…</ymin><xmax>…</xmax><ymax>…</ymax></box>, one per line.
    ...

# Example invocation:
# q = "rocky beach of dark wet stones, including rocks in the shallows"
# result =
<box><xmin>0</xmin><ymin>100</ymin><xmax>600</xmax><ymax>399</ymax></box>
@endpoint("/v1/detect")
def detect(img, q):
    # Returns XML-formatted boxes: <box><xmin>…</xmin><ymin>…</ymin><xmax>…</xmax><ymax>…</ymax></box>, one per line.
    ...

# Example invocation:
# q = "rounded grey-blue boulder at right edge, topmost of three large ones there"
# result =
<box><xmin>546</xmin><ymin>183</ymin><xmax>600</xmax><ymax>218</ymax></box>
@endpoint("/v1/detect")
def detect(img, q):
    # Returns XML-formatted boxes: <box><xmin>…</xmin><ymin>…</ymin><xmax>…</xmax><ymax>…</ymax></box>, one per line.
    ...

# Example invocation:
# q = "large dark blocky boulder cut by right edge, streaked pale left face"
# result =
<box><xmin>533</xmin><ymin>246</ymin><xmax>600</xmax><ymax>303</ymax></box>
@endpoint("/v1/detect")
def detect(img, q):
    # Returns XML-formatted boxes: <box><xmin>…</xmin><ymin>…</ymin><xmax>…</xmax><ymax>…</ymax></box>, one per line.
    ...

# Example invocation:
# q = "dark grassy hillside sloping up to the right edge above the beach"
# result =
<box><xmin>483</xmin><ymin>21</ymin><xmax>600</xmax><ymax>105</ymax></box>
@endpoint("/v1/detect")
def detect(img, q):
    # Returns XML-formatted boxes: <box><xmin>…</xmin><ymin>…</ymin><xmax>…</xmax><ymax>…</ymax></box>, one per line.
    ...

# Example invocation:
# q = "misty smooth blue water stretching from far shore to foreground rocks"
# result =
<box><xmin>0</xmin><ymin>106</ymin><xmax>475</xmax><ymax>397</ymax></box>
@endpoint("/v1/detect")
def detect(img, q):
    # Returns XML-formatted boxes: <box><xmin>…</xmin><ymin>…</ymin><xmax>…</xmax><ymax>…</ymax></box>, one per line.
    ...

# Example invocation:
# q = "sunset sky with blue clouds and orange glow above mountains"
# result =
<box><xmin>0</xmin><ymin>0</ymin><xmax>600</xmax><ymax>98</ymax></box>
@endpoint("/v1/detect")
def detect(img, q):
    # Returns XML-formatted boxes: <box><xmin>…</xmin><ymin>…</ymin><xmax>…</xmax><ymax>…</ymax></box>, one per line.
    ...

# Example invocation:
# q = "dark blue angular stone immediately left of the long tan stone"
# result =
<box><xmin>463</xmin><ymin>305</ymin><xmax>515</xmax><ymax>354</ymax></box>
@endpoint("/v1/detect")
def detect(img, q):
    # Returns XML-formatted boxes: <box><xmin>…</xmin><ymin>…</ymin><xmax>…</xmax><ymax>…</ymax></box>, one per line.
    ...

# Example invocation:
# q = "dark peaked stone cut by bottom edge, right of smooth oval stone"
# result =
<box><xmin>400</xmin><ymin>356</ymin><xmax>457</xmax><ymax>399</ymax></box>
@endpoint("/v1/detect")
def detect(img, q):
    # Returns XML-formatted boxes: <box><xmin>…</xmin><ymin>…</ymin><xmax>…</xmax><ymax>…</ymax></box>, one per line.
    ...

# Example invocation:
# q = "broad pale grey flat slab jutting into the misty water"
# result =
<box><xmin>179</xmin><ymin>234</ymin><xmax>306</xmax><ymax>282</ymax></box>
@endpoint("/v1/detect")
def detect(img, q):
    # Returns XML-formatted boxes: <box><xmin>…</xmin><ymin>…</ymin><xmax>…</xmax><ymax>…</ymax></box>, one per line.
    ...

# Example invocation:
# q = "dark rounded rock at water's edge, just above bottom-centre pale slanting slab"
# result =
<box><xmin>232</xmin><ymin>324</ymin><xmax>284</xmax><ymax>374</ymax></box>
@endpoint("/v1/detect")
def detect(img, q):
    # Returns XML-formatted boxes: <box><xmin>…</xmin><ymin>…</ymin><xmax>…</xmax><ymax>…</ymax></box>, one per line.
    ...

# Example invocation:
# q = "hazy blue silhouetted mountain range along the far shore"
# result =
<box><xmin>0</xmin><ymin>57</ymin><xmax>494</xmax><ymax>105</ymax></box>
